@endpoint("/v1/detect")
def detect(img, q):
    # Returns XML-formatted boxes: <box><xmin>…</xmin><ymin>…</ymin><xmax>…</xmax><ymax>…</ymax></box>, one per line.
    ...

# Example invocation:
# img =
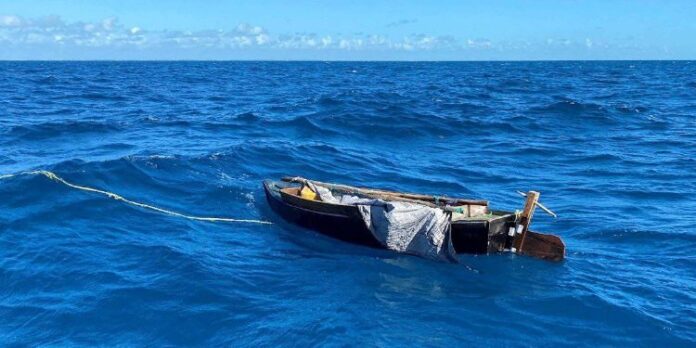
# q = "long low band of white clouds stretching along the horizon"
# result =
<box><xmin>0</xmin><ymin>15</ymin><xmax>668</xmax><ymax>60</ymax></box>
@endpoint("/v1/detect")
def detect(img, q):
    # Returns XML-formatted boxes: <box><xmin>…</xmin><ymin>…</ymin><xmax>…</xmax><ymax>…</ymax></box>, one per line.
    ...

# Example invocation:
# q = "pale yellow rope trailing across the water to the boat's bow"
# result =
<box><xmin>0</xmin><ymin>170</ymin><xmax>272</xmax><ymax>225</ymax></box>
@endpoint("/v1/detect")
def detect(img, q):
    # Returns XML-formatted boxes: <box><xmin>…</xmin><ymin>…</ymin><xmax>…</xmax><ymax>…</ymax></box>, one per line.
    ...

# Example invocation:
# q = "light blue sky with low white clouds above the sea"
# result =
<box><xmin>0</xmin><ymin>0</ymin><xmax>696</xmax><ymax>60</ymax></box>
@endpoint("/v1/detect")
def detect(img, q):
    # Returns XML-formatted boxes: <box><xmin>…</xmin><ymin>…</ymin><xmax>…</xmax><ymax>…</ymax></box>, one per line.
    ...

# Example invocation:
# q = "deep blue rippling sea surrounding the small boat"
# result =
<box><xmin>0</xmin><ymin>61</ymin><xmax>696</xmax><ymax>347</ymax></box>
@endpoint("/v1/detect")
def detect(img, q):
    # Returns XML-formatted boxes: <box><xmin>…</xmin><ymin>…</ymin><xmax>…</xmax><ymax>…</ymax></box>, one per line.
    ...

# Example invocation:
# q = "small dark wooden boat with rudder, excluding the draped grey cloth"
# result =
<box><xmin>263</xmin><ymin>177</ymin><xmax>565</xmax><ymax>261</ymax></box>
